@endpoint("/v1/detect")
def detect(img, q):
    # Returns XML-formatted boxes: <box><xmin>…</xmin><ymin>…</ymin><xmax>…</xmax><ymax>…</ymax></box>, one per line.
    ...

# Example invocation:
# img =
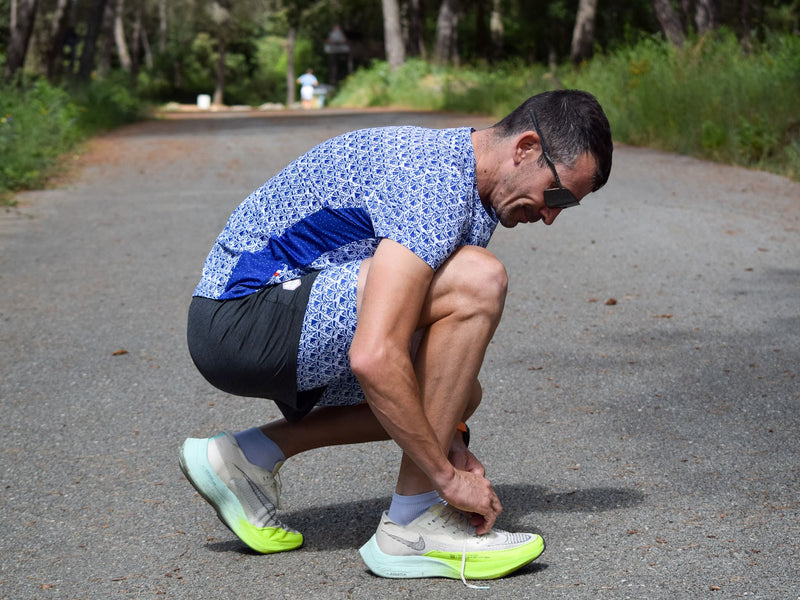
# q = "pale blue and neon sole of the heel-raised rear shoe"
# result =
<box><xmin>179</xmin><ymin>438</ymin><xmax>303</xmax><ymax>554</ymax></box>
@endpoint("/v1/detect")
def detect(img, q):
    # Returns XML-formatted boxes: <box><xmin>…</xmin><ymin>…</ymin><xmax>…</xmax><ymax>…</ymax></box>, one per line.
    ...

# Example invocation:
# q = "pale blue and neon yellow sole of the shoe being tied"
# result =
<box><xmin>359</xmin><ymin>535</ymin><xmax>545</xmax><ymax>579</ymax></box>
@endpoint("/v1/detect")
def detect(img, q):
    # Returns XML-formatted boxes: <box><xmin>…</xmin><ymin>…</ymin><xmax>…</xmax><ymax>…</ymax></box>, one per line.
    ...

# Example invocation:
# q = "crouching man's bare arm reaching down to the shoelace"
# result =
<box><xmin>350</xmin><ymin>239</ymin><xmax>499</xmax><ymax>533</ymax></box>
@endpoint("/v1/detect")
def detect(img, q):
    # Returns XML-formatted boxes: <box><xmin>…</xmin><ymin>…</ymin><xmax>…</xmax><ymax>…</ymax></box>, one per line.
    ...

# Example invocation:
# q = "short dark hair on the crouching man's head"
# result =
<box><xmin>494</xmin><ymin>90</ymin><xmax>614</xmax><ymax>192</ymax></box>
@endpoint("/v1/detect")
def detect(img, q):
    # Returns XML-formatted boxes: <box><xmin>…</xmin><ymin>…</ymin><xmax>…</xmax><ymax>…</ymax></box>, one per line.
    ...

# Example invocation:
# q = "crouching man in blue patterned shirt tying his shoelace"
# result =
<box><xmin>181</xmin><ymin>91</ymin><xmax>613</xmax><ymax>580</ymax></box>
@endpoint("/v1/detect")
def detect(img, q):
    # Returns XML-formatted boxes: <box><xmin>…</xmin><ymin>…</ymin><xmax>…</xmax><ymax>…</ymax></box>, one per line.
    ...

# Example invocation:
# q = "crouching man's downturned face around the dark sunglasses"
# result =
<box><xmin>492</xmin><ymin>153</ymin><xmax>595</xmax><ymax>227</ymax></box>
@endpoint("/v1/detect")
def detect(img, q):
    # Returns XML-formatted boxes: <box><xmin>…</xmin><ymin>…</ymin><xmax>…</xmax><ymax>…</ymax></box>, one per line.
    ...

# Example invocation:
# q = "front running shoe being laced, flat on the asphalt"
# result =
<box><xmin>360</xmin><ymin>503</ymin><xmax>544</xmax><ymax>583</ymax></box>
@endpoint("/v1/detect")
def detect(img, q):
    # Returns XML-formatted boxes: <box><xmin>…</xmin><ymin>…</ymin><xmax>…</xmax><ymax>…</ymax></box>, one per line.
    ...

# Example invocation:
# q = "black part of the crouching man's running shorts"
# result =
<box><xmin>187</xmin><ymin>272</ymin><xmax>325</xmax><ymax>421</ymax></box>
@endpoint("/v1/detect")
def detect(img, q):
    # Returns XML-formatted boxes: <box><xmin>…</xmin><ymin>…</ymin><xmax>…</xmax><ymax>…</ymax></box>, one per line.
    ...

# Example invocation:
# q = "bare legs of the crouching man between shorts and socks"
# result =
<box><xmin>261</xmin><ymin>246</ymin><xmax>507</xmax><ymax>495</ymax></box>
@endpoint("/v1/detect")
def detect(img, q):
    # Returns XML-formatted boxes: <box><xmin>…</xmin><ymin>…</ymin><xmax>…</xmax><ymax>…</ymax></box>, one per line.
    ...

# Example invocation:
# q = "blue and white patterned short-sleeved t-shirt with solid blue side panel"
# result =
<box><xmin>194</xmin><ymin>127</ymin><xmax>497</xmax><ymax>299</ymax></box>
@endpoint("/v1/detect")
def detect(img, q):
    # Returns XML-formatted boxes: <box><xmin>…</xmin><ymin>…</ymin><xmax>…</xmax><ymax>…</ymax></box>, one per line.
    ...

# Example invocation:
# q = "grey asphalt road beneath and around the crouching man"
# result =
<box><xmin>0</xmin><ymin>111</ymin><xmax>800</xmax><ymax>600</ymax></box>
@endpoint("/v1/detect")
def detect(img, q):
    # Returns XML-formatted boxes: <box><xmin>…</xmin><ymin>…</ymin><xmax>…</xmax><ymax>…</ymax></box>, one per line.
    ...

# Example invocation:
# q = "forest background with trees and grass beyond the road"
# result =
<box><xmin>0</xmin><ymin>0</ymin><xmax>800</xmax><ymax>201</ymax></box>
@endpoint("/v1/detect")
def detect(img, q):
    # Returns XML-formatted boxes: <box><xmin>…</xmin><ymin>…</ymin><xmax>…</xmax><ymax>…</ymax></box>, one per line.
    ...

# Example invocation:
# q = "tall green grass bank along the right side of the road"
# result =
<box><xmin>332</xmin><ymin>30</ymin><xmax>800</xmax><ymax>181</ymax></box>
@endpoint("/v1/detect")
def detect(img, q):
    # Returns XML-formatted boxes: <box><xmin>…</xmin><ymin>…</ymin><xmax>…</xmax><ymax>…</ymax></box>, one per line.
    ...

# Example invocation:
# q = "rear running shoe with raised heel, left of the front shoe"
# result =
<box><xmin>180</xmin><ymin>433</ymin><xmax>303</xmax><ymax>554</ymax></box>
